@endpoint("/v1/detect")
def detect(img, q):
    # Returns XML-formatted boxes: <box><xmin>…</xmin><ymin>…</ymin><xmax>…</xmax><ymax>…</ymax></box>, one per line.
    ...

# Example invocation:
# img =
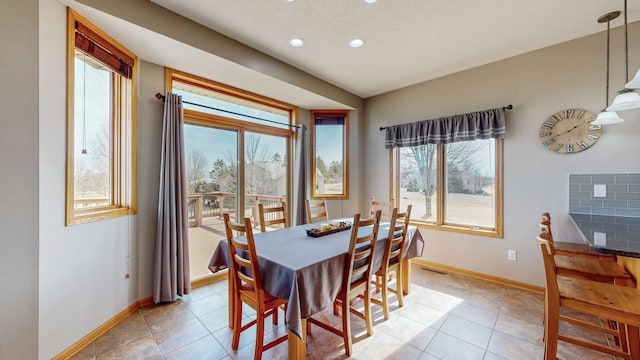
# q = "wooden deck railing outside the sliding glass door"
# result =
<box><xmin>187</xmin><ymin>191</ymin><xmax>286</xmax><ymax>227</ymax></box>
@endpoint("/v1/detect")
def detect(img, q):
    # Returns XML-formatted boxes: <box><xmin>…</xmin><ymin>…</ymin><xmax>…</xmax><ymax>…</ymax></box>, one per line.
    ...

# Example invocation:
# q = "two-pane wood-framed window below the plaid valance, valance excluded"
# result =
<box><xmin>391</xmin><ymin>139</ymin><xmax>503</xmax><ymax>237</ymax></box>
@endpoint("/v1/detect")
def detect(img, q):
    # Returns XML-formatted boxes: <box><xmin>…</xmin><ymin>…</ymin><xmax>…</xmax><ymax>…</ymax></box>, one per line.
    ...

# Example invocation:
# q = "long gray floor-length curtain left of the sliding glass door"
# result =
<box><xmin>153</xmin><ymin>93</ymin><xmax>191</xmax><ymax>304</ymax></box>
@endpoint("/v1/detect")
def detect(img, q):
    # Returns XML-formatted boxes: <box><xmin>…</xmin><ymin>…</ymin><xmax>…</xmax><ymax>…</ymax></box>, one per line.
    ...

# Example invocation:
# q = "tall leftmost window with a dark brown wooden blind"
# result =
<box><xmin>66</xmin><ymin>9</ymin><xmax>137</xmax><ymax>225</ymax></box>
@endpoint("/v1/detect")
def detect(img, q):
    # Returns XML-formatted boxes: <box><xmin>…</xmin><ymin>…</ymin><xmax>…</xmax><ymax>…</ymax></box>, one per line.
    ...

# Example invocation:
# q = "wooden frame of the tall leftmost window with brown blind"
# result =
<box><xmin>65</xmin><ymin>8</ymin><xmax>138</xmax><ymax>226</ymax></box>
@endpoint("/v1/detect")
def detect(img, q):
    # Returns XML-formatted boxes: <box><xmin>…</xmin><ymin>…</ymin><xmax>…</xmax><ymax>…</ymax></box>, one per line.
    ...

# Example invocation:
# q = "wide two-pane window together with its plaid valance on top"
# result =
<box><xmin>388</xmin><ymin>106</ymin><xmax>511</xmax><ymax>237</ymax></box>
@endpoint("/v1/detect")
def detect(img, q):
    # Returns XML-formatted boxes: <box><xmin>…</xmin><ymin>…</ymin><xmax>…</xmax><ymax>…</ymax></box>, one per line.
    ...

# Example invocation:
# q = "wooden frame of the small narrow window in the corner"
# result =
<box><xmin>309</xmin><ymin>110</ymin><xmax>349</xmax><ymax>200</ymax></box>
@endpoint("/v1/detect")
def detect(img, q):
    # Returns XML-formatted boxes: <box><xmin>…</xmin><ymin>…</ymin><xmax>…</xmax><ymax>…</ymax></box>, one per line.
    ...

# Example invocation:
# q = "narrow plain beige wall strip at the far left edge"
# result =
<box><xmin>0</xmin><ymin>0</ymin><xmax>40</xmax><ymax>359</ymax></box>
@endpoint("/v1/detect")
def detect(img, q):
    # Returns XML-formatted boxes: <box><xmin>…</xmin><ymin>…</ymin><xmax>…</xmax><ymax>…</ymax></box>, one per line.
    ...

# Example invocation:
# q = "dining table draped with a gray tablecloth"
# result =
<box><xmin>209</xmin><ymin>218</ymin><xmax>424</xmax><ymax>359</ymax></box>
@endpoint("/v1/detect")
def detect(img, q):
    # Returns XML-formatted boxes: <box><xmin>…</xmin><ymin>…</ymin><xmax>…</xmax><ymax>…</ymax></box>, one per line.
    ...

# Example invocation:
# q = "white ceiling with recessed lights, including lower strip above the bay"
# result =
<box><xmin>70</xmin><ymin>0</ymin><xmax>640</xmax><ymax>109</ymax></box>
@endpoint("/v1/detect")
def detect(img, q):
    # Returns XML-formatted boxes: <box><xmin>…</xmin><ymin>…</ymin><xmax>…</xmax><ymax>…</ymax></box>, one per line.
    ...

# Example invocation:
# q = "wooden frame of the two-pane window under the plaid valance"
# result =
<box><xmin>389</xmin><ymin>139</ymin><xmax>504</xmax><ymax>238</ymax></box>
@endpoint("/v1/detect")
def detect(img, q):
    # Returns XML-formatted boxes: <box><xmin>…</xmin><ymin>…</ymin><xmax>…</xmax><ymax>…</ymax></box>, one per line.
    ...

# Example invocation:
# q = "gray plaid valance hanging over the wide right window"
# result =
<box><xmin>384</xmin><ymin>108</ymin><xmax>505</xmax><ymax>149</ymax></box>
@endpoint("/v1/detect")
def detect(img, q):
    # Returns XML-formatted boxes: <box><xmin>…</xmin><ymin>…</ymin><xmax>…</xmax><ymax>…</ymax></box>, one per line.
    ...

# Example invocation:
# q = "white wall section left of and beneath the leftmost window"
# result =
<box><xmin>38</xmin><ymin>0</ymin><xmax>140</xmax><ymax>359</ymax></box>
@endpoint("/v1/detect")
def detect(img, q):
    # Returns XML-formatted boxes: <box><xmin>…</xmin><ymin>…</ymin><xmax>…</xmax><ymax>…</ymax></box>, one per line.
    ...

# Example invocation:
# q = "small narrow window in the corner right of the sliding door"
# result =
<box><xmin>311</xmin><ymin>110</ymin><xmax>349</xmax><ymax>199</ymax></box>
